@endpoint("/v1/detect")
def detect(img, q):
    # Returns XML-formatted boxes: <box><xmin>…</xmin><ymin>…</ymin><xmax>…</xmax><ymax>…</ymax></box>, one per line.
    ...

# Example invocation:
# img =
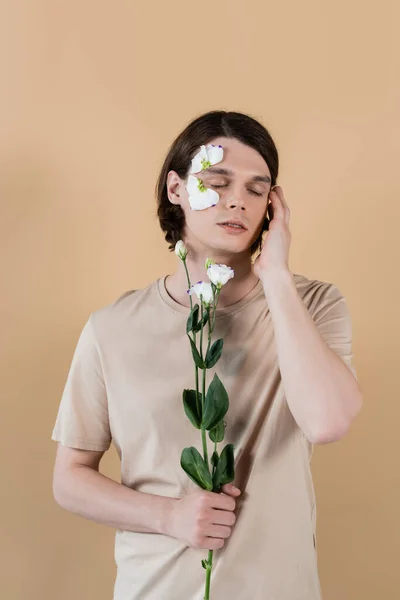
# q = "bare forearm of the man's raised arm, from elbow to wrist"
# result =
<box><xmin>263</xmin><ymin>271</ymin><xmax>361</xmax><ymax>443</ymax></box>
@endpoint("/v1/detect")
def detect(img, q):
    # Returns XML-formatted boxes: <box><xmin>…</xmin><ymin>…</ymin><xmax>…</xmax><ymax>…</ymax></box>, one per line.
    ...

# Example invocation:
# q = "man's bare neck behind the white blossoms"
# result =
<box><xmin>165</xmin><ymin>246</ymin><xmax>259</xmax><ymax>308</ymax></box>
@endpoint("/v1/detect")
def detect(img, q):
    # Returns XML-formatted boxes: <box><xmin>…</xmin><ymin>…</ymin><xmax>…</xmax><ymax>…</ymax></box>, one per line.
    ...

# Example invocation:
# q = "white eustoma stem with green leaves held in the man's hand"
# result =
<box><xmin>175</xmin><ymin>240</ymin><xmax>235</xmax><ymax>600</ymax></box>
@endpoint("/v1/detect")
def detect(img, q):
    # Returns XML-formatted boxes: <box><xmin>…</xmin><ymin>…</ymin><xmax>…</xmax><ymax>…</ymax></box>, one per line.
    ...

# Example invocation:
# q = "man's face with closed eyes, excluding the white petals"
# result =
<box><xmin>169</xmin><ymin>137</ymin><xmax>271</xmax><ymax>254</ymax></box>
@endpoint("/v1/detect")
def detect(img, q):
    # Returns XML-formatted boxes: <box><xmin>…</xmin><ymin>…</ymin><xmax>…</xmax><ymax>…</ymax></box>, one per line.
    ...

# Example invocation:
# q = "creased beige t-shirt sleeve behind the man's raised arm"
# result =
<box><xmin>312</xmin><ymin>284</ymin><xmax>357</xmax><ymax>379</ymax></box>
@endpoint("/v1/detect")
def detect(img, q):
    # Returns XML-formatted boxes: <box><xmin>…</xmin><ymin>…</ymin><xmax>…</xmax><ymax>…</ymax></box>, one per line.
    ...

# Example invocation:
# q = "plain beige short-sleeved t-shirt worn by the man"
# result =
<box><xmin>52</xmin><ymin>275</ymin><xmax>355</xmax><ymax>600</ymax></box>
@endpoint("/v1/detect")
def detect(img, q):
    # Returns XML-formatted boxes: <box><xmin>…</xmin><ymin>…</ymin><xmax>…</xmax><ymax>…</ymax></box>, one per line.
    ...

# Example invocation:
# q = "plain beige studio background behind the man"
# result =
<box><xmin>0</xmin><ymin>0</ymin><xmax>400</xmax><ymax>600</ymax></box>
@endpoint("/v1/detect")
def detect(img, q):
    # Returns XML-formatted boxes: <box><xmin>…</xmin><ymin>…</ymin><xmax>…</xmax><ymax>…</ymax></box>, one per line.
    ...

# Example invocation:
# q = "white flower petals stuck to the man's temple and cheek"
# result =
<box><xmin>186</xmin><ymin>144</ymin><xmax>224</xmax><ymax>210</ymax></box>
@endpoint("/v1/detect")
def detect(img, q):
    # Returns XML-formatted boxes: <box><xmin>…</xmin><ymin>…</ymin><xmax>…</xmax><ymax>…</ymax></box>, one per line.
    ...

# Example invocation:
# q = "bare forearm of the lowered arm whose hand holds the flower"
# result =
<box><xmin>54</xmin><ymin>465</ymin><xmax>177</xmax><ymax>534</ymax></box>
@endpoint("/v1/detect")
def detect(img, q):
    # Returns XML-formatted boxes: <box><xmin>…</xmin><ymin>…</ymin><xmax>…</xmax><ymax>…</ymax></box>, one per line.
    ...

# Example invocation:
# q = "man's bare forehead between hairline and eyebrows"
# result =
<box><xmin>203</xmin><ymin>137</ymin><xmax>271</xmax><ymax>177</ymax></box>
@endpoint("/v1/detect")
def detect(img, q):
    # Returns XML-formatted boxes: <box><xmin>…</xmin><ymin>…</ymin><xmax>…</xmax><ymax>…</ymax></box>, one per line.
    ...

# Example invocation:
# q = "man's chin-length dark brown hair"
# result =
<box><xmin>156</xmin><ymin>110</ymin><xmax>279</xmax><ymax>255</ymax></box>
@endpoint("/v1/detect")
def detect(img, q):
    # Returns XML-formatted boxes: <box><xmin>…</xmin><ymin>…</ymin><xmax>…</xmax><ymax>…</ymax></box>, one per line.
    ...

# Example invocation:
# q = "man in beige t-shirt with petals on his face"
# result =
<box><xmin>52</xmin><ymin>111</ymin><xmax>362</xmax><ymax>600</ymax></box>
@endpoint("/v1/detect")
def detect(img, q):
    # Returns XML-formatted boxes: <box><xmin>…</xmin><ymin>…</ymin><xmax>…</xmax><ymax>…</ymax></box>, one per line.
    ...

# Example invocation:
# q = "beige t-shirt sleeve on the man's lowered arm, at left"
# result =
<box><xmin>52</xmin><ymin>314</ymin><xmax>111</xmax><ymax>451</ymax></box>
